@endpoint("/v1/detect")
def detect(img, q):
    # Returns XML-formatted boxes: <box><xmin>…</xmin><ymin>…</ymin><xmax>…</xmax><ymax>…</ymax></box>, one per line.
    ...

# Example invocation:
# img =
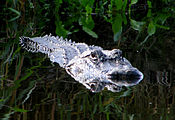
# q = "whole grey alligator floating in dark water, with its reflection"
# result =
<box><xmin>20</xmin><ymin>35</ymin><xmax>143</xmax><ymax>92</ymax></box>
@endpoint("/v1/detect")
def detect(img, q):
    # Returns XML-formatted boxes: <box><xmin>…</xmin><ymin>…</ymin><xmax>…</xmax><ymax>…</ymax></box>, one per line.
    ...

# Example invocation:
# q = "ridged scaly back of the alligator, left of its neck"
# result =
<box><xmin>20</xmin><ymin>35</ymin><xmax>73</xmax><ymax>68</ymax></box>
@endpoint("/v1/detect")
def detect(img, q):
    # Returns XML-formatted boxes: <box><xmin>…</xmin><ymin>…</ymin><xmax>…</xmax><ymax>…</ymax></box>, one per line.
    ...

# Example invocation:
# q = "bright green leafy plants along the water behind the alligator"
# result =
<box><xmin>2</xmin><ymin>0</ymin><xmax>175</xmax><ymax>41</ymax></box>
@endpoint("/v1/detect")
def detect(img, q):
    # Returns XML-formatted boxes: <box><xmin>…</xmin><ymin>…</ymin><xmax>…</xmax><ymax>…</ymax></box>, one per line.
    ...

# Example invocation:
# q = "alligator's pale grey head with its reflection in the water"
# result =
<box><xmin>66</xmin><ymin>49</ymin><xmax>143</xmax><ymax>92</ymax></box>
